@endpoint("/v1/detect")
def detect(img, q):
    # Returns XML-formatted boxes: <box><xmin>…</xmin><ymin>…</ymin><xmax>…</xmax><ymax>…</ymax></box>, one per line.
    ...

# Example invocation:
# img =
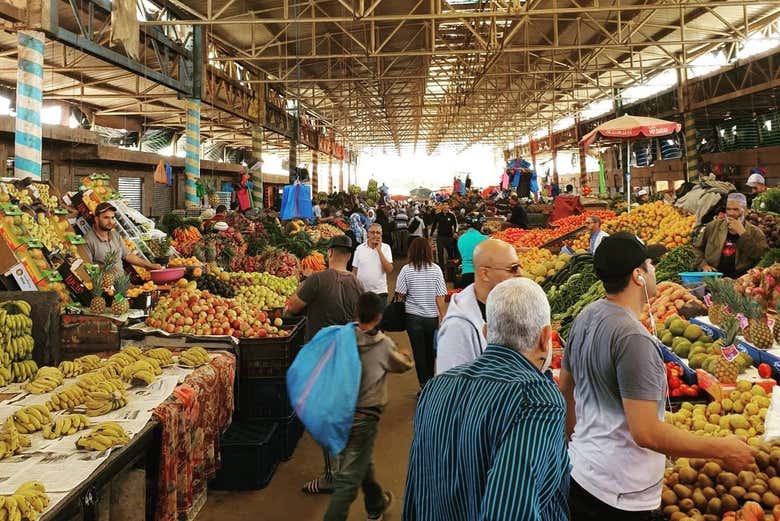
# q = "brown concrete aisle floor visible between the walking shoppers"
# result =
<box><xmin>195</xmin><ymin>261</ymin><xmax>419</xmax><ymax>521</ymax></box>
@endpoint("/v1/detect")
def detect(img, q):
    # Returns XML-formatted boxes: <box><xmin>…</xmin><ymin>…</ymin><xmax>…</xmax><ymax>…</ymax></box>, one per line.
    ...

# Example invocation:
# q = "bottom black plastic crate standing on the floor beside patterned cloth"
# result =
<box><xmin>209</xmin><ymin>420</ymin><xmax>282</xmax><ymax>490</ymax></box>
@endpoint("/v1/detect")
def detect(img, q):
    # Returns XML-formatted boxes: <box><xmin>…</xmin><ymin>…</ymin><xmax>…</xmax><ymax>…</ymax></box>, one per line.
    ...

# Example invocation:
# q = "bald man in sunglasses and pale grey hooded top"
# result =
<box><xmin>436</xmin><ymin>239</ymin><xmax>520</xmax><ymax>374</ymax></box>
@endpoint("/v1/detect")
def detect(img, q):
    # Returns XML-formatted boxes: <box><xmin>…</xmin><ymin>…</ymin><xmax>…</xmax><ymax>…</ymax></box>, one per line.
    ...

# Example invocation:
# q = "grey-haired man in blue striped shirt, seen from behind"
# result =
<box><xmin>403</xmin><ymin>279</ymin><xmax>569</xmax><ymax>521</ymax></box>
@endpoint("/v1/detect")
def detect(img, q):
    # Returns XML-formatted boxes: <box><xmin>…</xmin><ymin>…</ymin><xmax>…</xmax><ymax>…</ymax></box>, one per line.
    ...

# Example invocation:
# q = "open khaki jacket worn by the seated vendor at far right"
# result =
<box><xmin>693</xmin><ymin>219</ymin><xmax>769</xmax><ymax>274</ymax></box>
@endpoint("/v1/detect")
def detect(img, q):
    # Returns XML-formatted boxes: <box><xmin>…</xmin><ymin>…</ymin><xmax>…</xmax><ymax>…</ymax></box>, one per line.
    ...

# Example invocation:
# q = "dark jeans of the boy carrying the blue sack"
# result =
<box><xmin>325</xmin><ymin>414</ymin><xmax>385</xmax><ymax>521</ymax></box>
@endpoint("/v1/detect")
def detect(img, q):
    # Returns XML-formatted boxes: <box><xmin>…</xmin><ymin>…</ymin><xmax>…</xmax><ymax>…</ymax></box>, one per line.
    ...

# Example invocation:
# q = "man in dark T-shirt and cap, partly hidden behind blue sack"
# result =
<box><xmin>287</xmin><ymin>235</ymin><xmax>363</xmax><ymax>494</ymax></box>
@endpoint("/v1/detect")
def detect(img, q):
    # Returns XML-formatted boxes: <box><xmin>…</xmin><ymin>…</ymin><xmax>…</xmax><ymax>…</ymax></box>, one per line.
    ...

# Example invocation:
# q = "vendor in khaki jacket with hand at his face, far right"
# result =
<box><xmin>693</xmin><ymin>193</ymin><xmax>769</xmax><ymax>278</ymax></box>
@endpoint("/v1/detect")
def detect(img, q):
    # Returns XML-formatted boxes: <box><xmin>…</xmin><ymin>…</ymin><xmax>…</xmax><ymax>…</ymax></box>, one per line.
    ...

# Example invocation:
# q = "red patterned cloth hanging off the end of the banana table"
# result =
<box><xmin>154</xmin><ymin>352</ymin><xmax>236</xmax><ymax>521</ymax></box>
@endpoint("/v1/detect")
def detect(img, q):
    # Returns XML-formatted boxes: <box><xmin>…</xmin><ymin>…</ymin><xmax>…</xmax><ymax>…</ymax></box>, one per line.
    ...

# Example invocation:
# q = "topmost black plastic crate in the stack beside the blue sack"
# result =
<box><xmin>237</xmin><ymin>317</ymin><xmax>306</xmax><ymax>380</ymax></box>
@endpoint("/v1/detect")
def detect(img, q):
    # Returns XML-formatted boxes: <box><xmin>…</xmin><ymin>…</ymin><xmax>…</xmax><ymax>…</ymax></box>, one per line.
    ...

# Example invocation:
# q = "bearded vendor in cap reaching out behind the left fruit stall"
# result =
<box><xmin>84</xmin><ymin>202</ymin><xmax>162</xmax><ymax>274</ymax></box>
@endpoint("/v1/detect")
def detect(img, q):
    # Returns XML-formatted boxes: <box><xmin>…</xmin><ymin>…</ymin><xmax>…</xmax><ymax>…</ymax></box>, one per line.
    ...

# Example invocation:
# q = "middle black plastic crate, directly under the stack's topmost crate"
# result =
<box><xmin>236</xmin><ymin>378</ymin><xmax>292</xmax><ymax>420</ymax></box>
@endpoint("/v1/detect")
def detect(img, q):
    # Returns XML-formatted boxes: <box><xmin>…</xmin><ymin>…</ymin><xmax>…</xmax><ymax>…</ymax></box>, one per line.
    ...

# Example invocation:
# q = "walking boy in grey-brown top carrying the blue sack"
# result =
<box><xmin>325</xmin><ymin>290</ymin><xmax>414</xmax><ymax>521</ymax></box>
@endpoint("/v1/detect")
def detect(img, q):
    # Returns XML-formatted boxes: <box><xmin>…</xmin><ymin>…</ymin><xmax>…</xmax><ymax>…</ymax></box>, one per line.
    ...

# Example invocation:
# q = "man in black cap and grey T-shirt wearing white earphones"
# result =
<box><xmin>561</xmin><ymin>232</ymin><xmax>754</xmax><ymax>521</ymax></box>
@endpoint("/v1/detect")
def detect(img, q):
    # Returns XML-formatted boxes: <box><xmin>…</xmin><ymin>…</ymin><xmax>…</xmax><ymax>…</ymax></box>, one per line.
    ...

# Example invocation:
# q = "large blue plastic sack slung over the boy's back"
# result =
<box><xmin>287</xmin><ymin>323</ymin><xmax>362</xmax><ymax>454</ymax></box>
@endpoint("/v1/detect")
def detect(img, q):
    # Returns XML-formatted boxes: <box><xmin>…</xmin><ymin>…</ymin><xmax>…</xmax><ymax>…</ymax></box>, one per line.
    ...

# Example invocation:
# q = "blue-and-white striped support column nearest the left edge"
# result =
<box><xmin>14</xmin><ymin>31</ymin><xmax>44</xmax><ymax>179</ymax></box>
